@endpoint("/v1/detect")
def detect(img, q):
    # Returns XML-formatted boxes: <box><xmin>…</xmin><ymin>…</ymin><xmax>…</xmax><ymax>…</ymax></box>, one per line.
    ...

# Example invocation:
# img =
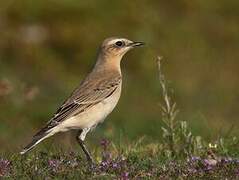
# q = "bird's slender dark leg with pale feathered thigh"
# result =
<box><xmin>76</xmin><ymin>128</ymin><xmax>93</xmax><ymax>164</ymax></box>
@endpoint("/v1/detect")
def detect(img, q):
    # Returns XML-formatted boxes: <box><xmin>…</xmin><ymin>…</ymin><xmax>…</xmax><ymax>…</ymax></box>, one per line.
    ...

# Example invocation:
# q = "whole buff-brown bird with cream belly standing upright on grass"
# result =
<box><xmin>20</xmin><ymin>37</ymin><xmax>144</xmax><ymax>163</ymax></box>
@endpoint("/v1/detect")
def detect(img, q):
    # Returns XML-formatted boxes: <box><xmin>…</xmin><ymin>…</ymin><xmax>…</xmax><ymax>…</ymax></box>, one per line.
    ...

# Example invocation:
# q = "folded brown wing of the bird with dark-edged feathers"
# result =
<box><xmin>35</xmin><ymin>75</ymin><xmax>121</xmax><ymax>136</ymax></box>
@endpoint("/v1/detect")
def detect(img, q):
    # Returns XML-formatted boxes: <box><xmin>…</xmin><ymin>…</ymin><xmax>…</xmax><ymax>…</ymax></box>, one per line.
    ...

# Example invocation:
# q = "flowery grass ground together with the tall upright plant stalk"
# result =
<box><xmin>0</xmin><ymin>58</ymin><xmax>239</xmax><ymax>179</ymax></box>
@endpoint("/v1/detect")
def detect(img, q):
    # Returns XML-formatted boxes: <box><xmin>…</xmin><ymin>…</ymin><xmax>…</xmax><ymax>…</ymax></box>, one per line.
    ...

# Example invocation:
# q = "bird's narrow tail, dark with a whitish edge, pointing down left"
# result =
<box><xmin>20</xmin><ymin>131</ymin><xmax>53</xmax><ymax>154</ymax></box>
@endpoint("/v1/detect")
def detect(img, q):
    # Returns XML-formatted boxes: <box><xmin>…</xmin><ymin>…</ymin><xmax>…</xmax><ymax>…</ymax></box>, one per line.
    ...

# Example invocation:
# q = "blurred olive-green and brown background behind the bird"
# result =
<box><xmin>0</xmin><ymin>0</ymin><xmax>239</xmax><ymax>152</ymax></box>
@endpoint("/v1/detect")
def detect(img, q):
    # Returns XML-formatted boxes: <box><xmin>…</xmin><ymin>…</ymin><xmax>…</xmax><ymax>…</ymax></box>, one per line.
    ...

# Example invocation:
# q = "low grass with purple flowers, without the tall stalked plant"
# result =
<box><xmin>0</xmin><ymin>140</ymin><xmax>239</xmax><ymax>179</ymax></box>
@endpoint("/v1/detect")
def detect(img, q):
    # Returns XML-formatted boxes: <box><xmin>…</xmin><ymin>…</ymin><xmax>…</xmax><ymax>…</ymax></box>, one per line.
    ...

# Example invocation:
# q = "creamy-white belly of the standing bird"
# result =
<box><xmin>59</xmin><ymin>88</ymin><xmax>121</xmax><ymax>131</ymax></box>
